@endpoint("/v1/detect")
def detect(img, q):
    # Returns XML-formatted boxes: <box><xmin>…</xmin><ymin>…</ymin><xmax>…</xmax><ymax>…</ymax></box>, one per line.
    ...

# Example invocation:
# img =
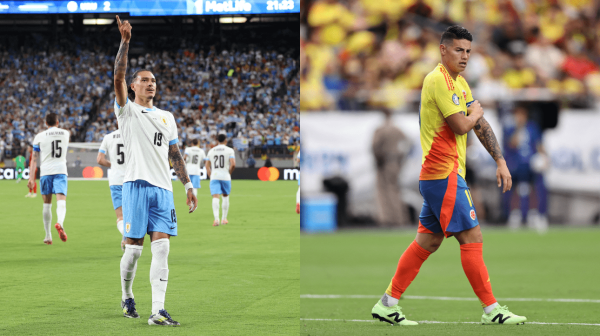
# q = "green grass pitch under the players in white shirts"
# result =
<box><xmin>0</xmin><ymin>180</ymin><xmax>300</xmax><ymax>335</ymax></box>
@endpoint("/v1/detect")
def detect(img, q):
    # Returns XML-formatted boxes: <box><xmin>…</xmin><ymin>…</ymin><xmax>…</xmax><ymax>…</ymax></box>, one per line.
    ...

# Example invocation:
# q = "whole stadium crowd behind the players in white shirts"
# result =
<box><xmin>0</xmin><ymin>36</ymin><xmax>300</xmax><ymax>161</ymax></box>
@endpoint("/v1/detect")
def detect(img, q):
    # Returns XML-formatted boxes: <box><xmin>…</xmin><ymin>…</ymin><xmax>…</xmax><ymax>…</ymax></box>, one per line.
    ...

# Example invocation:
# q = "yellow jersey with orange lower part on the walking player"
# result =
<box><xmin>419</xmin><ymin>64</ymin><xmax>473</xmax><ymax>180</ymax></box>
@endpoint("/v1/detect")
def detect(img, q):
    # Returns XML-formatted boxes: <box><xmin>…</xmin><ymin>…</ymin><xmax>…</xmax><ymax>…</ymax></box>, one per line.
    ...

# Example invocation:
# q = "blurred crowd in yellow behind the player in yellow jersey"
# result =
<box><xmin>300</xmin><ymin>0</ymin><xmax>600</xmax><ymax>111</ymax></box>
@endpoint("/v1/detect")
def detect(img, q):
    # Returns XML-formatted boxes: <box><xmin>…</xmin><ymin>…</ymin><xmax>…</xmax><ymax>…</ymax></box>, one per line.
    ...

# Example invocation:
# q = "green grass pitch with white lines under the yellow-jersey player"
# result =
<box><xmin>300</xmin><ymin>227</ymin><xmax>600</xmax><ymax>336</ymax></box>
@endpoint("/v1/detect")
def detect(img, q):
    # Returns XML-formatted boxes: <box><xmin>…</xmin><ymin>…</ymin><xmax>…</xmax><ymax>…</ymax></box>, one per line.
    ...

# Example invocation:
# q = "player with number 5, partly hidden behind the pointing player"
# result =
<box><xmin>96</xmin><ymin>130</ymin><xmax>125</xmax><ymax>251</ymax></box>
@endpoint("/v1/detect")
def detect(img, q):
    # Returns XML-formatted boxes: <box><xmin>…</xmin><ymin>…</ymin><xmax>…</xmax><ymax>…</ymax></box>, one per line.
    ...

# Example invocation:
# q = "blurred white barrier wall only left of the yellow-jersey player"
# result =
<box><xmin>301</xmin><ymin>112</ymin><xmax>421</xmax><ymax>215</ymax></box>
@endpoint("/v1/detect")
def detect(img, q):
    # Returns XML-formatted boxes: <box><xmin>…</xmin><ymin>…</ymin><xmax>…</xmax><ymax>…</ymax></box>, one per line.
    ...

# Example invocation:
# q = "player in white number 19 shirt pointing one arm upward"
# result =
<box><xmin>114</xmin><ymin>16</ymin><xmax>198</xmax><ymax>326</ymax></box>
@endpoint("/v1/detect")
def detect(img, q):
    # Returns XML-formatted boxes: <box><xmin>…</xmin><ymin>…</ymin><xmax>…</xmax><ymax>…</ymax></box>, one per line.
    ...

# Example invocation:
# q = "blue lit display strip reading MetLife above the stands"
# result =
<box><xmin>0</xmin><ymin>0</ymin><xmax>300</xmax><ymax>16</ymax></box>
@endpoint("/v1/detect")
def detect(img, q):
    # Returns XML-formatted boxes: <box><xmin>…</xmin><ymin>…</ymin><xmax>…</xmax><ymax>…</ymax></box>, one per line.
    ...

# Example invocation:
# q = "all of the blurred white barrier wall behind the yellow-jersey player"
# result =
<box><xmin>301</xmin><ymin>109</ymin><xmax>600</xmax><ymax>220</ymax></box>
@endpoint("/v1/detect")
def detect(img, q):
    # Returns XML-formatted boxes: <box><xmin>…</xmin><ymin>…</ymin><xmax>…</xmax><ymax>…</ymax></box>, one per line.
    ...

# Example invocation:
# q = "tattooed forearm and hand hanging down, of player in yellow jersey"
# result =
<box><xmin>473</xmin><ymin>117</ymin><xmax>512</xmax><ymax>192</ymax></box>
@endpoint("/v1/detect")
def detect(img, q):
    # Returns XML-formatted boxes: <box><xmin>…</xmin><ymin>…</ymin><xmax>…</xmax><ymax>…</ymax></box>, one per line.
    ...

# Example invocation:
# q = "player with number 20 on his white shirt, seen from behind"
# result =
<box><xmin>205</xmin><ymin>134</ymin><xmax>235</xmax><ymax>226</ymax></box>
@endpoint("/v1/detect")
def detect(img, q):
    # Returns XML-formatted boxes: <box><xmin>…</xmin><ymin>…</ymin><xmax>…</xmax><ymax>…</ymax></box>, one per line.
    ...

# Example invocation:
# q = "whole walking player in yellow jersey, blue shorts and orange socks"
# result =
<box><xmin>371</xmin><ymin>26</ymin><xmax>527</xmax><ymax>325</ymax></box>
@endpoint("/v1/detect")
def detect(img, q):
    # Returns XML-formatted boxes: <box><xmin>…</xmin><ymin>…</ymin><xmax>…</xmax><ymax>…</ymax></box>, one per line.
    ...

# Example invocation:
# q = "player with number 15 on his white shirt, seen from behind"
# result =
<box><xmin>27</xmin><ymin>112</ymin><xmax>71</xmax><ymax>245</ymax></box>
